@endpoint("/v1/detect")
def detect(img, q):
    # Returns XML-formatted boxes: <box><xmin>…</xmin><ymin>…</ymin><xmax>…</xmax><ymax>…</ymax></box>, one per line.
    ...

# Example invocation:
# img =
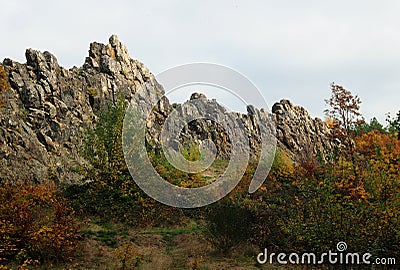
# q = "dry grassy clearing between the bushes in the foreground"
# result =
<box><xmin>35</xmin><ymin>220</ymin><xmax>283</xmax><ymax>269</ymax></box>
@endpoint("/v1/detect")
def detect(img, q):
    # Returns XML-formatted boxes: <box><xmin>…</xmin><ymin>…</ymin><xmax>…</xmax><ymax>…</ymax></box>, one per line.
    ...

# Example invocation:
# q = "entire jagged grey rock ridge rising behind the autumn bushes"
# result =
<box><xmin>0</xmin><ymin>35</ymin><xmax>331</xmax><ymax>182</ymax></box>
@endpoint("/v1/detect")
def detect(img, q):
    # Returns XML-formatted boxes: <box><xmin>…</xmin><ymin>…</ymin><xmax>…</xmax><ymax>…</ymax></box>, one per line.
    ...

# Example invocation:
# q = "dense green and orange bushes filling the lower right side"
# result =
<box><xmin>205</xmin><ymin>131</ymin><xmax>400</xmax><ymax>257</ymax></box>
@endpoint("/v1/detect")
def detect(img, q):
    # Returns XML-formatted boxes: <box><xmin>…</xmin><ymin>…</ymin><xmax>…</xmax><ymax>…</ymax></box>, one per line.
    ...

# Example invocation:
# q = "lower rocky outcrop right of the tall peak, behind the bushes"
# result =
<box><xmin>152</xmin><ymin>93</ymin><xmax>333</xmax><ymax>161</ymax></box>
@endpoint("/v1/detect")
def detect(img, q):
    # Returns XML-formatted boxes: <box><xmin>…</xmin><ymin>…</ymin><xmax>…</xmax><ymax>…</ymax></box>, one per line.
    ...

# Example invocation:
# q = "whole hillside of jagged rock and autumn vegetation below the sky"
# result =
<box><xmin>0</xmin><ymin>35</ymin><xmax>400</xmax><ymax>269</ymax></box>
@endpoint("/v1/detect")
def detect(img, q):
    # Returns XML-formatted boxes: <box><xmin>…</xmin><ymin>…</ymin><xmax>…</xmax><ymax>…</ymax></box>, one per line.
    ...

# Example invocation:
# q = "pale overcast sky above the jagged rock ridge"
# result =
<box><xmin>0</xmin><ymin>0</ymin><xmax>400</xmax><ymax>123</ymax></box>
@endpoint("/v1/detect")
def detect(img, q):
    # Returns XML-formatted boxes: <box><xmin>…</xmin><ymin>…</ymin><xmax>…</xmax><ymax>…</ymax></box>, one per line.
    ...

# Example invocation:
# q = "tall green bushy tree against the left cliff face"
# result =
<box><xmin>65</xmin><ymin>97</ymin><xmax>143</xmax><ymax>223</ymax></box>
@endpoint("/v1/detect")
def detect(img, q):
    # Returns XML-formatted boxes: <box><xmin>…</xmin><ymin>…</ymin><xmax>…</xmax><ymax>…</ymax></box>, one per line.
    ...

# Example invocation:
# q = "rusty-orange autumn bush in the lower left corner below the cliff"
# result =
<box><xmin>0</xmin><ymin>182</ymin><xmax>81</xmax><ymax>263</ymax></box>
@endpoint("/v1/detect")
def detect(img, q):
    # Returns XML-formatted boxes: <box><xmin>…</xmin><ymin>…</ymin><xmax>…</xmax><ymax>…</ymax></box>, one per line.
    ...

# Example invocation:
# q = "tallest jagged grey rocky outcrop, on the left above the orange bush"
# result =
<box><xmin>0</xmin><ymin>36</ymin><xmax>162</xmax><ymax>181</ymax></box>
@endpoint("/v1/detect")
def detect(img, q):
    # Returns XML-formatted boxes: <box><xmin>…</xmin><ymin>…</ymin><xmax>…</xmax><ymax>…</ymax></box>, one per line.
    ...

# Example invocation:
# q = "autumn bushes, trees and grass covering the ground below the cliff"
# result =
<box><xmin>0</xmin><ymin>84</ymin><xmax>400</xmax><ymax>269</ymax></box>
